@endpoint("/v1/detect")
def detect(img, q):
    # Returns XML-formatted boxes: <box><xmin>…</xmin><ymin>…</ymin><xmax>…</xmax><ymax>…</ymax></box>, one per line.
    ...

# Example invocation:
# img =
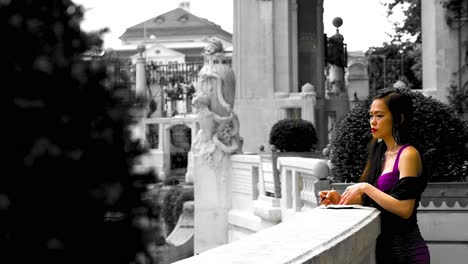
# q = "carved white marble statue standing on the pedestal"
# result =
<box><xmin>192</xmin><ymin>40</ymin><xmax>242</xmax><ymax>166</ymax></box>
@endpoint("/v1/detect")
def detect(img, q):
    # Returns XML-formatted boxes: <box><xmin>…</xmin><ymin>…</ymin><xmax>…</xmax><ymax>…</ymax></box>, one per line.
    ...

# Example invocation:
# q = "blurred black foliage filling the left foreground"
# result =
<box><xmin>0</xmin><ymin>0</ymin><xmax>159</xmax><ymax>263</ymax></box>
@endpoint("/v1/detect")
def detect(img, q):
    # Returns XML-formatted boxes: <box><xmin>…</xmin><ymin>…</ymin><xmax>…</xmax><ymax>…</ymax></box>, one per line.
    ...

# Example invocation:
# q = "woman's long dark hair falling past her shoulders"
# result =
<box><xmin>359</xmin><ymin>89</ymin><xmax>413</xmax><ymax>185</ymax></box>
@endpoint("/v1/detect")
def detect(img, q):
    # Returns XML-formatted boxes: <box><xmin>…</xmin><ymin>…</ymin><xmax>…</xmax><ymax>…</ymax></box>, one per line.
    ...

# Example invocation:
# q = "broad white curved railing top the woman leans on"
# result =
<box><xmin>175</xmin><ymin>207</ymin><xmax>380</xmax><ymax>264</ymax></box>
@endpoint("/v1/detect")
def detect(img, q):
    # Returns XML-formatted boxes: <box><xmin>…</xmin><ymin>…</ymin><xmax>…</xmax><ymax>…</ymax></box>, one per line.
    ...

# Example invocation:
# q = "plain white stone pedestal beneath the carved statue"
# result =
<box><xmin>193</xmin><ymin>155</ymin><xmax>231</xmax><ymax>254</ymax></box>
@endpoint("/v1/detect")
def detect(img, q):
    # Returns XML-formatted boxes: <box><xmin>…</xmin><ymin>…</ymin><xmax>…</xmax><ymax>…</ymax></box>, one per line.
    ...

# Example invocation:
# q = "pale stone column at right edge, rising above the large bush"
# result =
<box><xmin>421</xmin><ymin>0</ymin><xmax>468</xmax><ymax>103</ymax></box>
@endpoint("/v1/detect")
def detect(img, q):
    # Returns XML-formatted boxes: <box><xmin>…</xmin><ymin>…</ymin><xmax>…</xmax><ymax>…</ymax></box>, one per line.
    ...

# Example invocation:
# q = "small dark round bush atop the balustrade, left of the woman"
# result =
<box><xmin>269</xmin><ymin>119</ymin><xmax>317</xmax><ymax>152</ymax></box>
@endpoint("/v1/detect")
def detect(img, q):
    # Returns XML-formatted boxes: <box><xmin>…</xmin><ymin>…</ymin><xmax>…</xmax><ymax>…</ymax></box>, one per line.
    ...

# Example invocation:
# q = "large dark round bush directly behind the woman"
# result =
<box><xmin>330</xmin><ymin>89</ymin><xmax>468</xmax><ymax>182</ymax></box>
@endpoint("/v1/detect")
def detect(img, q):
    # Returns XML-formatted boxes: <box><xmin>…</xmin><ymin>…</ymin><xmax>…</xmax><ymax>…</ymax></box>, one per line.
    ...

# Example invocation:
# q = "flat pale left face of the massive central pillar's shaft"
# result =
<box><xmin>233</xmin><ymin>0</ymin><xmax>274</xmax><ymax>99</ymax></box>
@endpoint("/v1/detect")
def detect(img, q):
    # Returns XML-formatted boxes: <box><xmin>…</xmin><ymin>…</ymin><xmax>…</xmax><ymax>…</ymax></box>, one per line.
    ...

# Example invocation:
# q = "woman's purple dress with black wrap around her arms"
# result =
<box><xmin>365</xmin><ymin>144</ymin><xmax>430</xmax><ymax>264</ymax></box>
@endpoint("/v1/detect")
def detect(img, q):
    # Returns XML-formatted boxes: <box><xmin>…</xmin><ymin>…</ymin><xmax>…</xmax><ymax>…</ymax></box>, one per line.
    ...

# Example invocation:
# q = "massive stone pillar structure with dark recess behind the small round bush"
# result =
<box><xmin>233</xmin><ymin>0</ymin><xmax>349</xmax><ymax>152</ymax></box>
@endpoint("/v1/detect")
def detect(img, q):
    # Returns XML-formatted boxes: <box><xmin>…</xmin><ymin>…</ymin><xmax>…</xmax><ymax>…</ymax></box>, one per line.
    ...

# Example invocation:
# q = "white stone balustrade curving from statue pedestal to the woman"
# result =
<box><xmin>176</xmin><ymin>155</ymin><xmax>380</xmax><ymax>264</ymax></box>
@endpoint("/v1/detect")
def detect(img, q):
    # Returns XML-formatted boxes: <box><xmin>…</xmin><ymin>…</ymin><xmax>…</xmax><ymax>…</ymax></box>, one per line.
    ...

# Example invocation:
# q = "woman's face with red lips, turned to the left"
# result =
<box><xmin>369</xmin><ymin>99</ymin><xmax>393</xmax><ymax>140</ymax></box>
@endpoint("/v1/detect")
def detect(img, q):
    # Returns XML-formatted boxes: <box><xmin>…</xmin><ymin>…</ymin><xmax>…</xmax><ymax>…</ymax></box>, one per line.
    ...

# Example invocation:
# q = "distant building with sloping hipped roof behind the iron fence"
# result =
<box><xmin>115</xmin><ymin>2</ymin><xmax>232</xmax><ymax>65</ymax></box>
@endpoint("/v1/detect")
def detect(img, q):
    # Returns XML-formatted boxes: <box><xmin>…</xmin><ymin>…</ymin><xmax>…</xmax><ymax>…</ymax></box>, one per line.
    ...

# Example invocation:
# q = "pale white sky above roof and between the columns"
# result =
<box><xmin>73</xmin><ymin>0</ymin><xmax>402</xmax><ymax>51</ymax></box>
